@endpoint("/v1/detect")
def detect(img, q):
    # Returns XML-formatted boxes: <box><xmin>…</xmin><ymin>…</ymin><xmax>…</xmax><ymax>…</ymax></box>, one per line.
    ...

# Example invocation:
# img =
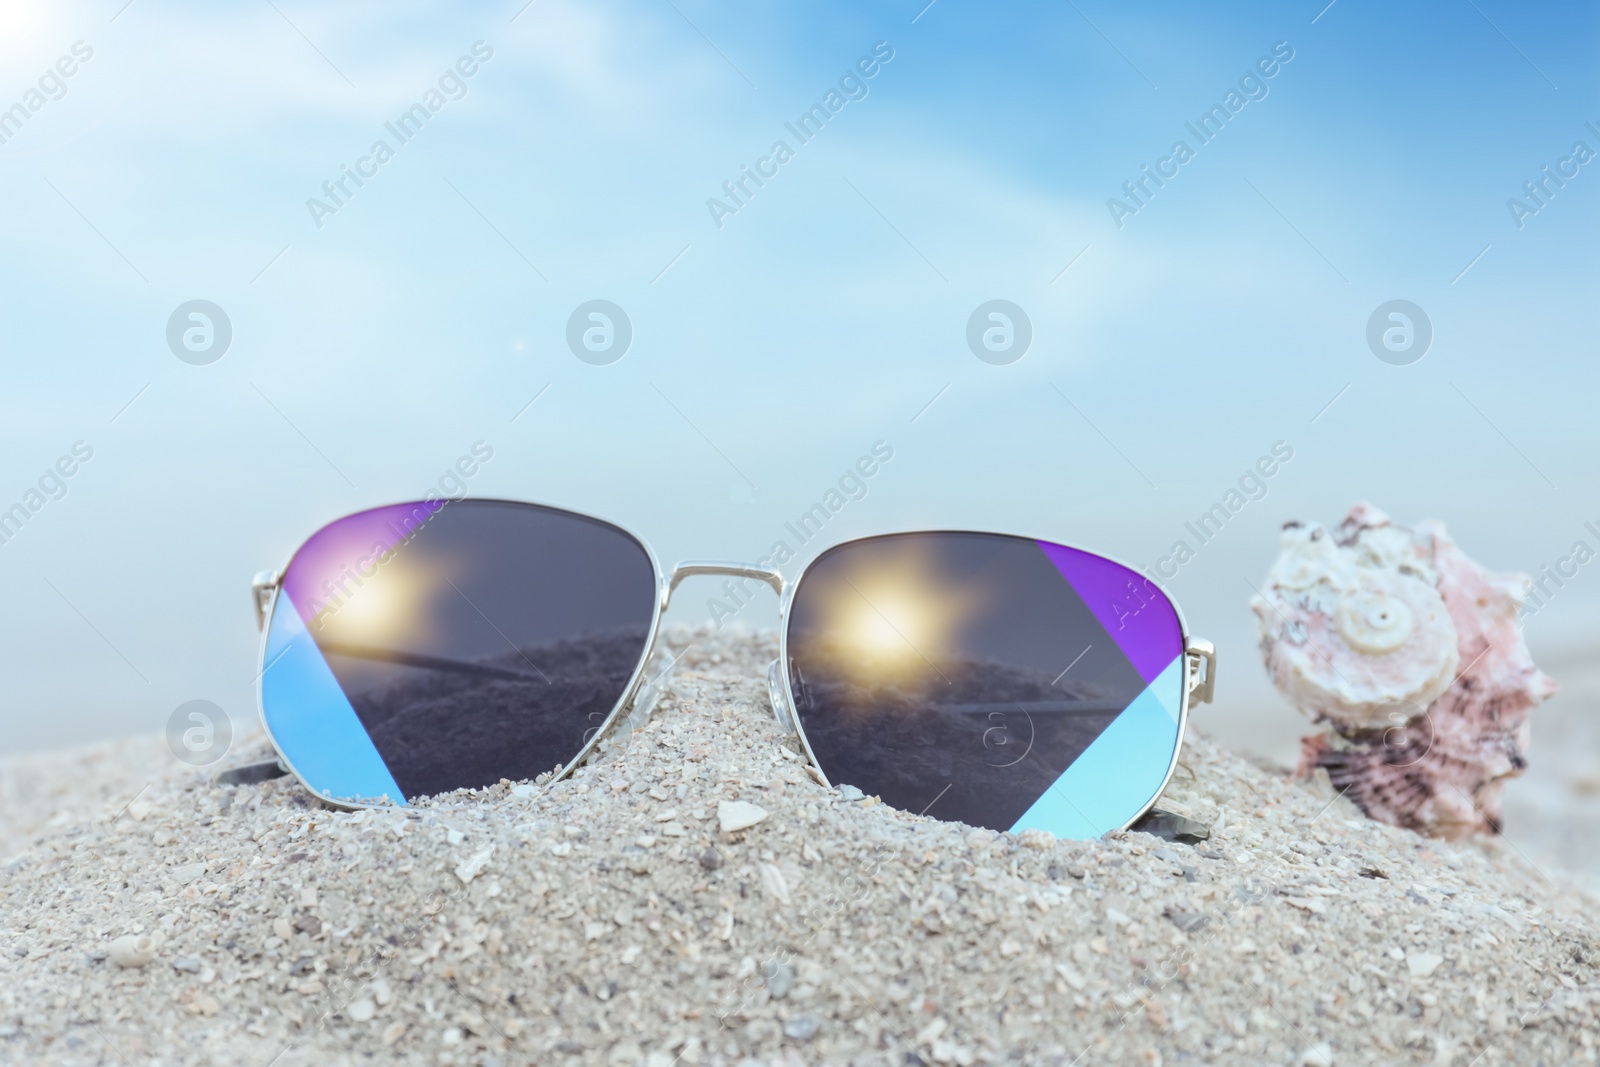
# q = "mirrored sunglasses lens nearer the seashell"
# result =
<box><xmin>786</xmin><ymin>533</ymin><xmax>1184</xmax><ymax>838</ymax></box>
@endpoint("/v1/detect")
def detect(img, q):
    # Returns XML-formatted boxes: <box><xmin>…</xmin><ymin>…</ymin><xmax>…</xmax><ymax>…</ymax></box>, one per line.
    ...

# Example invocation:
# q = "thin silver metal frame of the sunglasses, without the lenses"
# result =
<box><xmin>251</xmin><ymin>508</ymin><xmax>1216</xmax><ymax>830</ymax></box>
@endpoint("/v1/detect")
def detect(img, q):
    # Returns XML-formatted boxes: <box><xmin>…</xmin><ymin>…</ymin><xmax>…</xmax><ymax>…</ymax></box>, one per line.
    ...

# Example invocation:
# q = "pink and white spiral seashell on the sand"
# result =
<box><xmin>1250</xmin><ymin>504</ymin><xmax>1557</xmax><ymax>838</ymax></box>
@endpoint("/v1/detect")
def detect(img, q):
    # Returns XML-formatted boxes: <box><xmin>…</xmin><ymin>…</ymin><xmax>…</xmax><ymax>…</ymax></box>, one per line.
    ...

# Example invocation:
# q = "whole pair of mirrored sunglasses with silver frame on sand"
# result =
<box><xmin>233</xmin><ymin>499</ymin><xmax>1216</xmax><ymax>838</ymax></box>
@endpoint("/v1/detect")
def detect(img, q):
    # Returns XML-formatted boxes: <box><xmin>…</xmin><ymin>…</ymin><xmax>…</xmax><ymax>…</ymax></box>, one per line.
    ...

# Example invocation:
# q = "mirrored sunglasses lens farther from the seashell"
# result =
<box><xmin>261</xmin><ymin>501</ymin><xmax>656</xmax><ymax>803</ymax></box>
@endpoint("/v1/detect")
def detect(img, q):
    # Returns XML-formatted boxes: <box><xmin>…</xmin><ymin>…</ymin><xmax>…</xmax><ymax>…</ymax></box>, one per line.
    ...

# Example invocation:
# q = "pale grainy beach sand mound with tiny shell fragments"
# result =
<box><xmin>0</xmin><ymin>632</ymin><xmax>1600</xmax><ymax>1067</ymax></box>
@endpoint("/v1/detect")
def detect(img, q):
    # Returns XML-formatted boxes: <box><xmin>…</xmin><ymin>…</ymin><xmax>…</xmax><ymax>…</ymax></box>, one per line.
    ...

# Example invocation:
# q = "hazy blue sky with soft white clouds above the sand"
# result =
<box><xmin>0</xmin><ymin>0</ymin><xmax>1600</xmax><ymax>752</ymax></box>
